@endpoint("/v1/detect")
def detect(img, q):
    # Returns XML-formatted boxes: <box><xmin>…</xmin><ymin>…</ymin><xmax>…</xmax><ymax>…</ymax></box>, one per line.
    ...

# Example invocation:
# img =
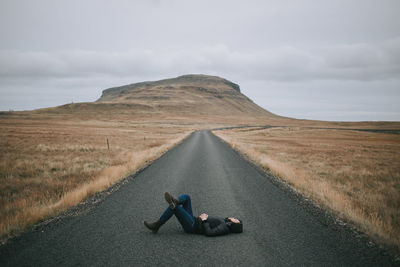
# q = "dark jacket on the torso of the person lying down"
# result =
<box><xmin>194</xmin><ymin>216</ymin><xmax>230</xmax><ymax>236</ymax></box>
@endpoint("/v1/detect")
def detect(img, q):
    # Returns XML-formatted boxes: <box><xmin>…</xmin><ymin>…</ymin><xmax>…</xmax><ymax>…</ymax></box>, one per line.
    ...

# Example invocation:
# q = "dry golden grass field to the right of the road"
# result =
<box><xmin>215</xmin><ymin>126</ymin><xmax>400</xmax><ymax>251</ymax></box>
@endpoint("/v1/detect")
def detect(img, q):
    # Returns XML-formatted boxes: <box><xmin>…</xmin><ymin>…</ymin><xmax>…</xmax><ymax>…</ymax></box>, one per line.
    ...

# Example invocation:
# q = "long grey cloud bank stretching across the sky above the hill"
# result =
<box><xmin>0</xmin><ymin>37</ymin><xmax>400</xmax><ymax>81</ymax></box>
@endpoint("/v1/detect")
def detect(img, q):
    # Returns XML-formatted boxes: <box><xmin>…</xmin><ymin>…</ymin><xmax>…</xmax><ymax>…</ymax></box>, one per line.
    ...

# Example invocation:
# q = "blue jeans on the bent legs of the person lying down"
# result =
<box><xmin>160</xmin><ymin>195</ymin><xmax>195</xmax><ymax>233</ymax></box>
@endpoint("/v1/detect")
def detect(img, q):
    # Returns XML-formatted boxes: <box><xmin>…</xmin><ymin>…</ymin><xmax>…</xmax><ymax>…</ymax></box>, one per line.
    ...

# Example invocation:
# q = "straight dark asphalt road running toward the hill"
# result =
<box><xmin>0</xmin><ymin>131</ymin><xmax>395</xmax><ymax>266</ymax></box>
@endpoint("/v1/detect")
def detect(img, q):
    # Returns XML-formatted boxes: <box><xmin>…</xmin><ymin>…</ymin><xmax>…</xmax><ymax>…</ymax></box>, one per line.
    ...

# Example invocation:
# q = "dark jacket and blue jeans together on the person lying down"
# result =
<box><xmin>160</xmin><ymin>195</ymin><xmax>231</xmax><ymax>236</ymax></box>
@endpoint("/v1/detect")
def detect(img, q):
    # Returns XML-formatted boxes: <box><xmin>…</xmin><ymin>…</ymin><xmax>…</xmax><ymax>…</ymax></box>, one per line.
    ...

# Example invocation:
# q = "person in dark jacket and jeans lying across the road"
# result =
<box><xmin>144</xmin><ymin>192</ymin><xmax>243</xmax><ymax>236</ymax></box>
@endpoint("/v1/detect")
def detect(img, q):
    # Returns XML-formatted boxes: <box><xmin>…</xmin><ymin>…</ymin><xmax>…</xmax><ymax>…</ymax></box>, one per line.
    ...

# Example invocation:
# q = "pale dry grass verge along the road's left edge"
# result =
<box><xmin>0</xmin><ymin>131</ymin><xmax>192</xmax><ymax>244</ymax></box>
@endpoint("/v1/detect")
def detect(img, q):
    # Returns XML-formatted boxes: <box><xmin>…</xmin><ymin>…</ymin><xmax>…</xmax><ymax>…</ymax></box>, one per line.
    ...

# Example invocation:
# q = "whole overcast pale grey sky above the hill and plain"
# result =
<box><xmin>0</xmin><ymin>0</ymin><xmax>400</xmax><ymax>121</ymax></box>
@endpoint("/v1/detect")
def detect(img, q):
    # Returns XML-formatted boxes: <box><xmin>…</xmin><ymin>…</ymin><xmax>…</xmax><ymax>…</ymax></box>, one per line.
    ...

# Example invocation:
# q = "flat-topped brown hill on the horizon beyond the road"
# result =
<box><xmin>31</xmin><ymin>74</ymin><xmax>281</xmax><ymax>121</ymax></box>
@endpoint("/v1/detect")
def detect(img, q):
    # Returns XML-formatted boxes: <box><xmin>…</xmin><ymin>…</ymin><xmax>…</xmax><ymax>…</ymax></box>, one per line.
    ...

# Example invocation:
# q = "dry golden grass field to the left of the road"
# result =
<box><xmin>0</xmin><ymin>113</ymin><xmax>192</xmax><ymax>244</ymax></box>
